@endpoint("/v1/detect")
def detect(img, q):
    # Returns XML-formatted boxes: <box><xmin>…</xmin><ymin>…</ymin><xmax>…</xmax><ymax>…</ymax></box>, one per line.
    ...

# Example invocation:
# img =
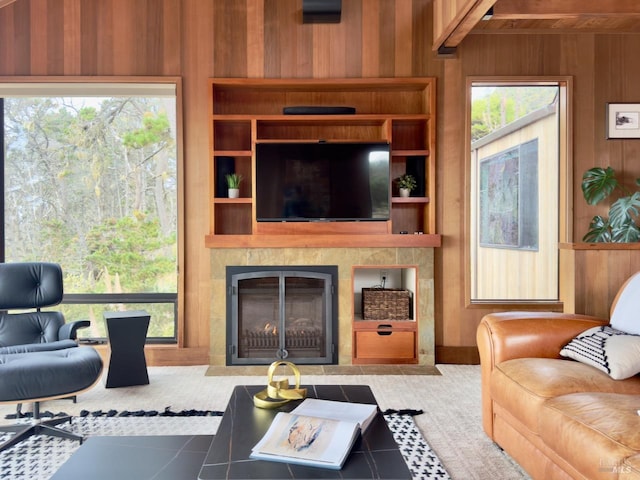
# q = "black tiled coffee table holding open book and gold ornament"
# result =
<box><xmin>198</xmin><ymin>385</ymin><xmax>411</xmax><ymax>480</ymax></box>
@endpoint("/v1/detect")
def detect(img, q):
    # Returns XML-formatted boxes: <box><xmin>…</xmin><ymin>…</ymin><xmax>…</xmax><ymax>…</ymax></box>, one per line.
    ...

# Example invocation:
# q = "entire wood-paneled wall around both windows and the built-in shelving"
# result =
<box><xmin>0</xmin><ymin>0</ymin><xmax>640</xmax><ymax>363</ymax></box>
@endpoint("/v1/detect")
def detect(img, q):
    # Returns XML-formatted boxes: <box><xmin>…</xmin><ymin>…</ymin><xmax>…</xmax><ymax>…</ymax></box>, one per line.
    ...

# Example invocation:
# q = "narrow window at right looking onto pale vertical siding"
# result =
<box><xmin>469</xmin><ymin>80</ymin><xmax>568</xmax><ymax>304</ymax></box>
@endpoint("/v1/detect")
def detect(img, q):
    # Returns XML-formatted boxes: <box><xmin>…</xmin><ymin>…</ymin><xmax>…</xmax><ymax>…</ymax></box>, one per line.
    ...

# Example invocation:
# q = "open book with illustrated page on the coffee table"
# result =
<box><xmin>251</xmin><ymin>398</ymin><xmax>377</xmax><ymax>470</ymax></box>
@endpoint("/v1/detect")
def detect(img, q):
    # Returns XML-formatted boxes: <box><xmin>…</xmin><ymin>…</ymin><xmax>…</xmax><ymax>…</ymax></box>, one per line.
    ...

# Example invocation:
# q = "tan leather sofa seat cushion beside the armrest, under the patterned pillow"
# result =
<box><xmin>491</xmin><ymin>358</ymin><xmax>640</xmax><ymax>434</ymax></box>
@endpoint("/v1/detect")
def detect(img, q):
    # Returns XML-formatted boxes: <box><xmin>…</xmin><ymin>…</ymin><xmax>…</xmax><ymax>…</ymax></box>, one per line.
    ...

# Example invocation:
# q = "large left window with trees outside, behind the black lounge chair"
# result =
<box><xmin>0</xmin><ymin>82</ymin><xmax>179</xmax><ymax>342</ymax></box>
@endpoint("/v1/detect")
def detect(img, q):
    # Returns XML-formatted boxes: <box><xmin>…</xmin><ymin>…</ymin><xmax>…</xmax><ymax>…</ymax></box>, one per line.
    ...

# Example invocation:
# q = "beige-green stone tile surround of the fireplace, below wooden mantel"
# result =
<box><xmin>209</xmin><ymin>247</ymin><xmax>435</xmax><ymax>366</ymax></box>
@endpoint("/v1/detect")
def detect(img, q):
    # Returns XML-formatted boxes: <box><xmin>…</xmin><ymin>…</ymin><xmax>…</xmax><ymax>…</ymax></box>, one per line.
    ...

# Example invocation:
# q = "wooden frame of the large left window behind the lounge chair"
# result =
<box><xmin>0</xmin><ymin>76</ymin><xmax>185</xmax><ymax>347</ymax></box>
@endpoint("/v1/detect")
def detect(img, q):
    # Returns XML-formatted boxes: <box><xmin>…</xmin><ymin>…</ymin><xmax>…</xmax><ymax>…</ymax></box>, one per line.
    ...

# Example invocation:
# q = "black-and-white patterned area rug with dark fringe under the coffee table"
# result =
<box><xmin>0</xmin><ymin>408</ymin><xmax>450</xmax><ymax>480</ymax></box>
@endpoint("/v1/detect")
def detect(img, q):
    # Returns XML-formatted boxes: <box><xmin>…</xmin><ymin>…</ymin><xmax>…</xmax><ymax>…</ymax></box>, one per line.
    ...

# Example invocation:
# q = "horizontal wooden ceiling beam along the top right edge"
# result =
<box><xmin>493</xmin><ymin>0</ymin><xmax>640</xmax><ymax>20</ymax></box>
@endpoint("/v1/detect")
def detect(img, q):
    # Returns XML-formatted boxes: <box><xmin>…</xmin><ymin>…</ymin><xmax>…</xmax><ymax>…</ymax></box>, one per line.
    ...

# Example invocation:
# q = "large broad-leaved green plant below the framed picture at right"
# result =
<box><xmin>582</xmin><ymin>167</ymin><xmax>640</xmax><ymax>243</ymax></box>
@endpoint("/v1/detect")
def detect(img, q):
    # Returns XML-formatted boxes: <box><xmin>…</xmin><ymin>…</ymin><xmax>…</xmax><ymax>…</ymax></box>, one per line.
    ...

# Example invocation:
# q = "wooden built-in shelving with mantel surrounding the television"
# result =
<box><xmin>205</xmin><ymin>78</ymin><xmax>441</xmax><ymax>248</ymax></box>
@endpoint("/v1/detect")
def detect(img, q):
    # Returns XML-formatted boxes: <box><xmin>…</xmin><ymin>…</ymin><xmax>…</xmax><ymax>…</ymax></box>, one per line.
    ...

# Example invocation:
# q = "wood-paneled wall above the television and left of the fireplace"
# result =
<box><xmin>0</xmin><ymin>0</ymin><xmax>442</xmax><ymax>364</ymax></box>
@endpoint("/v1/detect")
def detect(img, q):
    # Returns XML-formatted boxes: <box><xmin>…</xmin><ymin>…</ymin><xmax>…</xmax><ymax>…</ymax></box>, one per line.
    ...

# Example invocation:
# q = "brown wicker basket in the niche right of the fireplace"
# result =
<box><xmin>362</xmin><ymin>288</ymin><xmax>411</xmax><ymax>320</ymax></box>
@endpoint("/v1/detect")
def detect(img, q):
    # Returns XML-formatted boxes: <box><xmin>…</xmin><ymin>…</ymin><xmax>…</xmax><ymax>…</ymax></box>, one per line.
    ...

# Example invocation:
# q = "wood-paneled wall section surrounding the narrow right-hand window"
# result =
<box><xmin>435</xmin><ymin>33</ymin><xmax>640</xmax><ymax>361</ymax></box>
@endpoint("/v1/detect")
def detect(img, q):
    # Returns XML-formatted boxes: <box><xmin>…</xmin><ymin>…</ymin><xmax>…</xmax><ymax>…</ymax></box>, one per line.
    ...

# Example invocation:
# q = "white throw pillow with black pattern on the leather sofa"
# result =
<box><xmin>560</xmin><ymin>326</ymin><xmax>640</xmax><ymax>380</ymax></box>
